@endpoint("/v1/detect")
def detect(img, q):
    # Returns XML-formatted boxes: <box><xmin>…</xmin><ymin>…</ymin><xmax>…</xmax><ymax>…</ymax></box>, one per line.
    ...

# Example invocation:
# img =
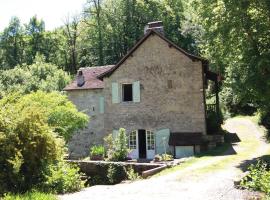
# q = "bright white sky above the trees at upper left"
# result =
<box><xmin>0</xmin><ymin>0</ymin><xmax>86</xmax><ymax>32</ymax></box>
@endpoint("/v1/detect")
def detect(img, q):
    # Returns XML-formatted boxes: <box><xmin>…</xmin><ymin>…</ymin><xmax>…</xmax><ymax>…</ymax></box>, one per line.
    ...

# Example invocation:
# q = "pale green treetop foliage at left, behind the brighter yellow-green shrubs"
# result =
<box><xmin>0</xmin><ymin>58</ymin><xmax>71</xmax><ymax>96</ymax></box>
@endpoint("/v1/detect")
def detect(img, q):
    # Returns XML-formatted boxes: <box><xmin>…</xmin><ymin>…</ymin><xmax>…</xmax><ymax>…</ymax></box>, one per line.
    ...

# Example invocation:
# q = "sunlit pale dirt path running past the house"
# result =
<box><xmin>60</xmin><ymin>118</ymin><xmax>269</xmax><ymax>200</ymax></box>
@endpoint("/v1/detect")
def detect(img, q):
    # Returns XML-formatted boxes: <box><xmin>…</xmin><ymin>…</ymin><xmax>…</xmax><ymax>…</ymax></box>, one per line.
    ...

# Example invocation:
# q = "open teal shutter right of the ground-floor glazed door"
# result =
<box><xmin>155</xmin><ymin>129</ymin><xmax>170</xmax><ymax>154</ymax></box>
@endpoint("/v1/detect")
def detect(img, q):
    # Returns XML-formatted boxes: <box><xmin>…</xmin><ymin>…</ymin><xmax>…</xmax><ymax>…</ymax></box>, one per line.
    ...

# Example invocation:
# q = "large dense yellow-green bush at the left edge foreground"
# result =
<box><xmin>0</xmin><ymin>104</ymin><xmax>64</xmax><ymax>194</ymax></box>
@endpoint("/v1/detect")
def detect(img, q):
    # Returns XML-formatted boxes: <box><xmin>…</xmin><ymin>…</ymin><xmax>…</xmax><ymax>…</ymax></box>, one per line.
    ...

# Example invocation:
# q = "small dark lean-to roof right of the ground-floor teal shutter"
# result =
<box><xmin>169</xmin><ymin>132</ymin><xmax>203</xmax><ymax>146</ymax></box>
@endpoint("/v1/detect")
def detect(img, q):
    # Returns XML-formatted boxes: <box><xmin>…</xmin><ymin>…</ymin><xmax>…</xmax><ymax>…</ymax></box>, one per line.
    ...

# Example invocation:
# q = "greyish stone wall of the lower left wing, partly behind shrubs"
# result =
<box><xmin>68</xmin><ymin>89</ymin><xmax>106</xmax><ymax>159</ymax></box>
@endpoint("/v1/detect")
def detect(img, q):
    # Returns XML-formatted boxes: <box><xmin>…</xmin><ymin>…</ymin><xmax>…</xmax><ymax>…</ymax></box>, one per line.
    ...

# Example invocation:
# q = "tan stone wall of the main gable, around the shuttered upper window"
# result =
<box><xmin>104</xmin><ymin>35</ymin><xmax>206</xmax><ymax>134</ymax></box>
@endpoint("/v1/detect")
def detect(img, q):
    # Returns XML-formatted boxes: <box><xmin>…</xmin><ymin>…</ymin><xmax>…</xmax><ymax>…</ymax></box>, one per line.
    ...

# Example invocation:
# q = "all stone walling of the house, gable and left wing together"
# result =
<box><xmin>65</xmin><ymin>30</ymin><xmax>209</xmax><ymax>158</ymax></box>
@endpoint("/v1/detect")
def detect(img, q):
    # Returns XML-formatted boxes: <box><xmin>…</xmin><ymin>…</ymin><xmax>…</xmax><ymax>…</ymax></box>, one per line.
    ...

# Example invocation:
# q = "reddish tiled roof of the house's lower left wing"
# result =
<box><xmin>64</xmin><ymin>65</ymin><xmax>114</xmax><ymax>91</ymax></box>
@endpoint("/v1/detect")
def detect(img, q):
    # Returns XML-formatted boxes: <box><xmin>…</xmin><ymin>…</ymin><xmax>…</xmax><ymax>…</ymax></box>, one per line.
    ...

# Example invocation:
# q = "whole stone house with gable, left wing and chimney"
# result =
<box><xmin>64</xmin><ymin>22</ymin><xmax>218</xmax><ymax>159</ymax></box>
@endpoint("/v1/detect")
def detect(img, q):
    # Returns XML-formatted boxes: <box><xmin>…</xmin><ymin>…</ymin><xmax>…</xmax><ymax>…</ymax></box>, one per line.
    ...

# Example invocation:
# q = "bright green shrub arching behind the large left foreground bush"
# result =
<box><xmin>0</xmin><ymin>91</ymin><xmax>88</xmax><ymax>141</ymax></box>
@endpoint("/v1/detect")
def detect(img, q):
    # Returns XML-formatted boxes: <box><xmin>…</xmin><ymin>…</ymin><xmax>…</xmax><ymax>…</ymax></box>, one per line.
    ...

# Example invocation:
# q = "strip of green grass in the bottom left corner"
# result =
<box><xmin>2</xmin><ymin>191</ymin><xmax>58</xmax><ymax>200</ymax></box>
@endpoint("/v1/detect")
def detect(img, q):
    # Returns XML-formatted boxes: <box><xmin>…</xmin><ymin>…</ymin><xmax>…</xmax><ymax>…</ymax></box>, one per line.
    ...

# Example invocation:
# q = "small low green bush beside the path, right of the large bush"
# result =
<box><xmin>40</xmin><ymin>161</ymin><xmax>85</xmax><ymax>194</ymax></box>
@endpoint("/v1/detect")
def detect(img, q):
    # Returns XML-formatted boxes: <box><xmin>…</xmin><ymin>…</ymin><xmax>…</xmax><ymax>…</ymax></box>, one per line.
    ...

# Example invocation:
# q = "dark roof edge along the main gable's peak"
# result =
<box><xmin>98</xmin><ymin>29</ymin><xmax>208</xmax><ymax>79</ymax></box>
